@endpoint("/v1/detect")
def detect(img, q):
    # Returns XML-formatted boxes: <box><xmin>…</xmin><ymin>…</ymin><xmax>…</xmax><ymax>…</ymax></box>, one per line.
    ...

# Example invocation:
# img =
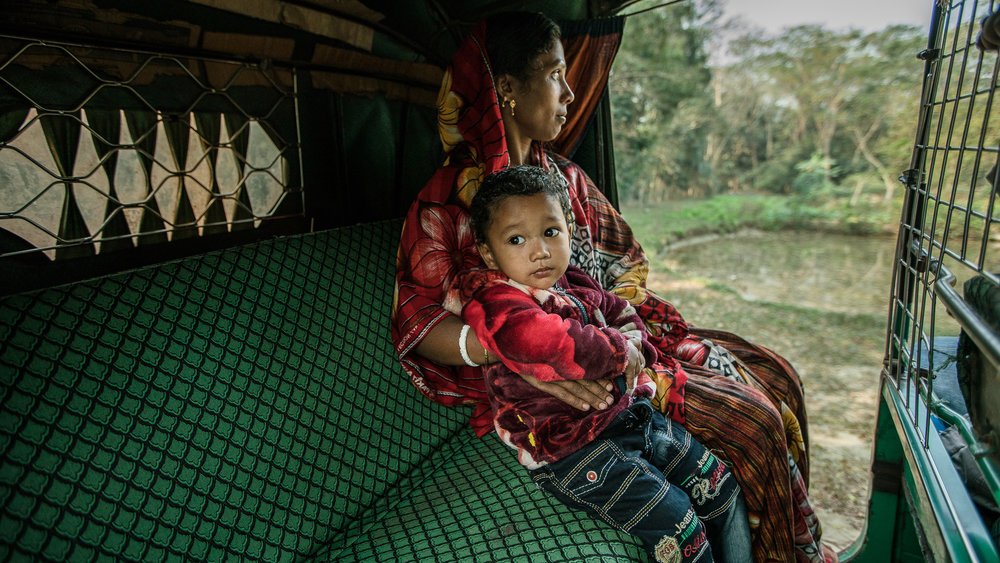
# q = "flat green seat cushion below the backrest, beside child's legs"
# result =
<box><xmin>317</xmin><ymin>430</ymin><xmax>645</xmax><ymax>561</ymax></box>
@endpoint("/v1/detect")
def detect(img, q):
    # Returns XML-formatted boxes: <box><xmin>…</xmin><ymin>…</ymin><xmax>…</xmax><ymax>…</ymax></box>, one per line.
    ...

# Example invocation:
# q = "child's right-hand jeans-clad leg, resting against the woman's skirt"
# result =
<box><xmin>650</xmin><ymin>411</ymin><xmax>752</xmax><ymax>563</ymax></box>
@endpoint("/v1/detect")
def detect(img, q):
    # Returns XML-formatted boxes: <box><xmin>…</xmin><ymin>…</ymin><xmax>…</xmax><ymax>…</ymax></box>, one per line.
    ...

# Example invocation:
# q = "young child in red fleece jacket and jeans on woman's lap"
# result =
<box><xmin>453</xmin><ymin>166</ymin><xmax>751</xmax><ymax>562</ymax></box>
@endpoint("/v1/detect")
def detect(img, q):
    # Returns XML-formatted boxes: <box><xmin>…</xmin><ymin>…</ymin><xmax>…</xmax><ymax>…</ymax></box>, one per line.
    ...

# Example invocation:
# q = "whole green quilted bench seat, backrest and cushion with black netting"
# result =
<box><xmin>0</xmin><ymin>221</ymin><xmax>639</xmax><ymax>561</ymax></box>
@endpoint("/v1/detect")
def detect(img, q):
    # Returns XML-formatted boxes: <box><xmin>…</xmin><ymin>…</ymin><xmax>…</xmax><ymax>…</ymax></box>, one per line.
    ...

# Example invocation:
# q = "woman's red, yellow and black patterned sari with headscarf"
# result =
<box><xmin>392</xmin><ymin>20</ymin><xmax>835</xmax><ymax>562</ymax></box>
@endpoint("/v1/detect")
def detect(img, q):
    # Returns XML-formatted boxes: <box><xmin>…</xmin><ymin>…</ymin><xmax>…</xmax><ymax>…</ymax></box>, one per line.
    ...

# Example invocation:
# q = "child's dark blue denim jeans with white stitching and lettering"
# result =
<box><xmin>531</xmin><ymin>400</ymin><xmax>752</xmax><ymax>563</ymax></box>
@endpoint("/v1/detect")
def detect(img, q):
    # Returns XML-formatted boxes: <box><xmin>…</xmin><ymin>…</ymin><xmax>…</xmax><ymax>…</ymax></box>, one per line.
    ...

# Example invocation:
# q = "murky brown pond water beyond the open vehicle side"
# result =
<box><xmin>661</xmin><ymin>231</ymin><xmax>896</xmax><ymax>314</ymax></box>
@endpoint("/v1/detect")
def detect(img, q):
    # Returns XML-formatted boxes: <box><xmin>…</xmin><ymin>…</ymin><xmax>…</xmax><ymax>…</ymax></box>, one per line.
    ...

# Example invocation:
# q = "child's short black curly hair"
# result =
<box><xmin>469</xmin><ymin>165</ymin><xmax>573</xmax><ymax>242</ymax></box>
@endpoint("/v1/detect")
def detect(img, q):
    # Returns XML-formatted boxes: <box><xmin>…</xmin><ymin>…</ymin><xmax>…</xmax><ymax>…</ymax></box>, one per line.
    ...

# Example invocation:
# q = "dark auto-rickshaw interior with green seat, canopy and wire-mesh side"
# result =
<box><xmin>0</xmin><ymin>0</ymin><xmax>1000</xmax><ymax>562</ymax></box>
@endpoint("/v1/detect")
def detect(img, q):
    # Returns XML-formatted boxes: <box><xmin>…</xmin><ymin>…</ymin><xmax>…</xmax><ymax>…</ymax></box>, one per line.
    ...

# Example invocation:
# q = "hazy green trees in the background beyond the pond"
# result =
<box><xmin>611</xmin><ymin>2</ymin><xmax>926</xmax><ymax>203</ymax></box>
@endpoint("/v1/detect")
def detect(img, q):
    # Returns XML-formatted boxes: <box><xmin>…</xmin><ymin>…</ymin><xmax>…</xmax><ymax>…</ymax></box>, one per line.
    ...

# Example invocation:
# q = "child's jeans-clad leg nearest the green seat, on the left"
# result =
<box><xmin>532</xmin><ymin>418</ymin><xmax>713</xmax><ymax>563</ymax></box>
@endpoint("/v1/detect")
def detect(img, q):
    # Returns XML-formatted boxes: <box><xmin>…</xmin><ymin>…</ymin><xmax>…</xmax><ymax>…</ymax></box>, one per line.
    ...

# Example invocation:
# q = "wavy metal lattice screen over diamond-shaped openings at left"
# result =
<box><xmin>0</xmin><ymin>37</ymin><xmax>303</xmax><ymax>260</ymax></box>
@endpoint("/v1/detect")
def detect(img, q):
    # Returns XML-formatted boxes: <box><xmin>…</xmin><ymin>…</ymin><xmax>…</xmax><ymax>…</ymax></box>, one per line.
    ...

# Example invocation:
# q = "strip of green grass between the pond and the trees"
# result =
<box><xmin>622</xmin><ymin>195</ymin><xmax>899</xmax><ymax>254</ymax></box>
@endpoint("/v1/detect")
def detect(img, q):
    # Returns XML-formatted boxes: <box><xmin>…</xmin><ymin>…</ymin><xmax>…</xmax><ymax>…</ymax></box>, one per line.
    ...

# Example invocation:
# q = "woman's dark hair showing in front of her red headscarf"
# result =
<box><xmin>486</xmin><ymin>12</ymin><xmax>562</xmax><ymax>80</ymax></box>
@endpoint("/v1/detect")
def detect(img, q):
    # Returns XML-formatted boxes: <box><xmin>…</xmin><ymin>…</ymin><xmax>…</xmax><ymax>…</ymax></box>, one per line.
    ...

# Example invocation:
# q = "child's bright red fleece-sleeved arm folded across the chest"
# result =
<box><xmin>462</xmin><ymin>283</ymin><xmax>630</xmax><ymax>381</ymax></box>
